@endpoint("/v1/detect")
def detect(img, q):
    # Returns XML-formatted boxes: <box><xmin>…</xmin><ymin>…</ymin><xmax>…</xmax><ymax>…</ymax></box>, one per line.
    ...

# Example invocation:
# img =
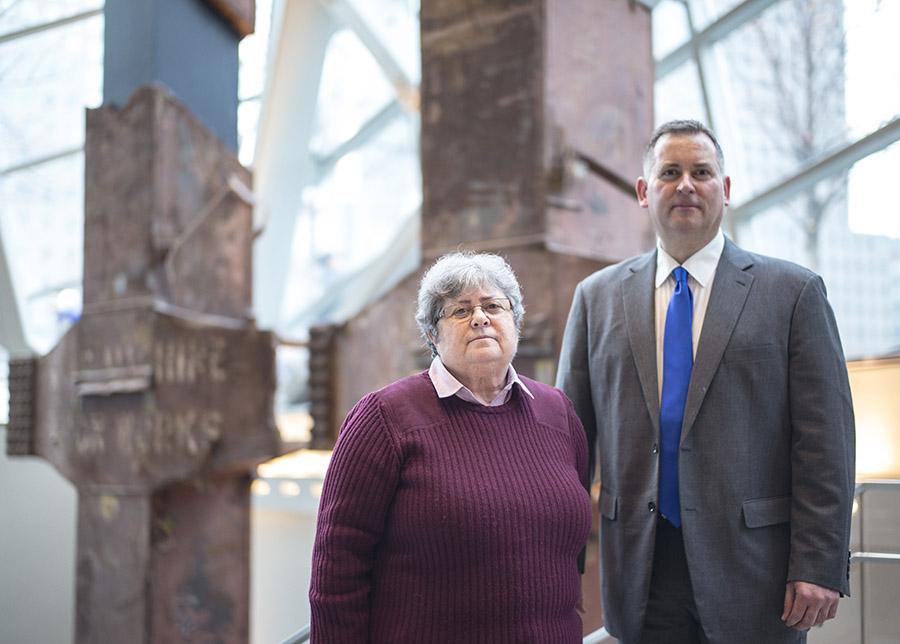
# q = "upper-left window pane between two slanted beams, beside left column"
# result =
<box><xmin>0</xmin><ymin>16</ymin><xmax>103</xmax><ymax>168</ymax></box>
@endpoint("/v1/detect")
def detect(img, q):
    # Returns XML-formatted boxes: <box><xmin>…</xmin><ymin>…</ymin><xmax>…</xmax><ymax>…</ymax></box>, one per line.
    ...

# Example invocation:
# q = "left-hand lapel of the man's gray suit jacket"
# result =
<box><xmin>622</xmin><ymin>251</ymin><xmax>659</xmax><ymax>433</ymax></box>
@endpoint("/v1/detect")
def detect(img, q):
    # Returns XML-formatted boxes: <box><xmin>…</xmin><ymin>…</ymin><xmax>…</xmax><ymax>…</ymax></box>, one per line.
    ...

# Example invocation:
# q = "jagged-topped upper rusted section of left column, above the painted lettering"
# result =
<box><xmin>84</xmin><ymin>87</ymin><xmax>253</xmax><ymax>318</ymax></box>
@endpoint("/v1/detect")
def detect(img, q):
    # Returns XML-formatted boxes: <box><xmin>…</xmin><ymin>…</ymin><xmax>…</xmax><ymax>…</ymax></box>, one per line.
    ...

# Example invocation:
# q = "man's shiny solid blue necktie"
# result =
<box><xmin>659</xmin><ymin>266</ymin><xmax>694</xmax><ymax>528</ymax></box>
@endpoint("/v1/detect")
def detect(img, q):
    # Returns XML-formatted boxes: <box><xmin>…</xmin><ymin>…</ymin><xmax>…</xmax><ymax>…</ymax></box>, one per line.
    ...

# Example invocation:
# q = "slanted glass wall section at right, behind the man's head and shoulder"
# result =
<box><xmin>653</xmin><ymin>0</ymin><xmax>900</xmax><ymax>358</ymax></box>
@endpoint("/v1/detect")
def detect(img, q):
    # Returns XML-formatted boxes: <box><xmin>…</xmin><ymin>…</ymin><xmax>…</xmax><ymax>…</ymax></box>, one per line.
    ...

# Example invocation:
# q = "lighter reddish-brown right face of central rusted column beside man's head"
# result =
<box><xmin>545</xmin><ymin>0</ymin><xmax>653</xmax><ymax>263</ymax></box>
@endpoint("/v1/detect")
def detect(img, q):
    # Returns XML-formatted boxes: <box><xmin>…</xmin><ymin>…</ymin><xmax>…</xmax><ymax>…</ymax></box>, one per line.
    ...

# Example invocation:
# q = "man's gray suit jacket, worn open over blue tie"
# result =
<box><xmin>557</xmin><ymin>240</ymin><xmax>855</xmax><ymax>644</ymax></box>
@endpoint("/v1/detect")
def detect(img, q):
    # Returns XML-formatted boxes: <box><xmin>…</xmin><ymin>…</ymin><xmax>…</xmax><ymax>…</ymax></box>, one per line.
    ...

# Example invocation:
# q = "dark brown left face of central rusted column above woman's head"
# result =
<box><xmin>421</xmin><ymin>0</ymin><xmax>544</xmax><ymax>255</ymax></box>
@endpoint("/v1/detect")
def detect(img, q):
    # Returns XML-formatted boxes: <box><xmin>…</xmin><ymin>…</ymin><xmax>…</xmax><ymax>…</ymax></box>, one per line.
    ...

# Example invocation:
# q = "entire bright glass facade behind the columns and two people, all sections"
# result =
<box><xmin>0</xmin><ymin>0</ymin><xmax>900</xmax><ymax>370</ymax></box>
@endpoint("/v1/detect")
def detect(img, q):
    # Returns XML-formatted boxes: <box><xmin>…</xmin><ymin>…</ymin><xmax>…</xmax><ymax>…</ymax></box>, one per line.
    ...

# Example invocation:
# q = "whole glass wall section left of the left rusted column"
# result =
<box><xmin>0</xmin><ymin>0</ymin><xmax>103</xmax><ymax>352</ymax></box>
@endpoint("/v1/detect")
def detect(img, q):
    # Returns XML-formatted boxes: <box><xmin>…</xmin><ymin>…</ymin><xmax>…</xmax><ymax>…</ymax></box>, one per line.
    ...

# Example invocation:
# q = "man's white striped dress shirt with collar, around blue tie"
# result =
<box><xmin>654</xmin><ymin>229</ymin><xmax>725</xmax><ymax>399</ymax></box>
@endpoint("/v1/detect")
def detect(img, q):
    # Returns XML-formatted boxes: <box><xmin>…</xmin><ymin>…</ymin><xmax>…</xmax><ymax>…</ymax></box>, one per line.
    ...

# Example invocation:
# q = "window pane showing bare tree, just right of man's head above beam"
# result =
<box><xmin>704</xmin><ymin>0</ymin><xmax>849</xmax><ymax>203</ymax></box>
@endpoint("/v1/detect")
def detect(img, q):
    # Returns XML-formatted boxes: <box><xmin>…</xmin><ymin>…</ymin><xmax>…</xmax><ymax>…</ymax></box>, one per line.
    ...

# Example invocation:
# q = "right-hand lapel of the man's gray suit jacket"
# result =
<box><xmin>681</xmin><ymin>239</ymin><xmax>753</xmax><ymax>443</ymax></box>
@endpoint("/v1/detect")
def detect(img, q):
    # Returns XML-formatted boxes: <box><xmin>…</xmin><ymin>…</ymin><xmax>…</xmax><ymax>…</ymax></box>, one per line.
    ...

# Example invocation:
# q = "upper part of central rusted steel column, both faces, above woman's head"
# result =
<box><xmin>421</xmin><ymin>0</ymin><xmax>653</xmax><ymax>262</ymax></box>
